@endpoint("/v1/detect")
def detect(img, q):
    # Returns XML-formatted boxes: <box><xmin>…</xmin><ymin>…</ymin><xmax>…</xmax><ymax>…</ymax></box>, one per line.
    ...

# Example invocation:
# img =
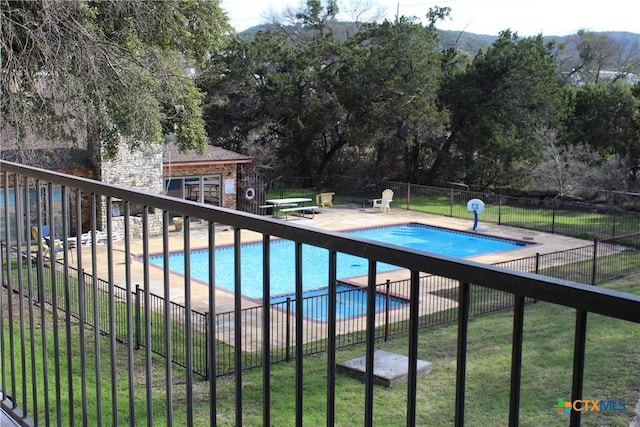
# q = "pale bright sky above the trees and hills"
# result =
<box><xmin>221</xmin><ymin>0</ymin><xmax>640</xmax><ymax>37</ymax></box>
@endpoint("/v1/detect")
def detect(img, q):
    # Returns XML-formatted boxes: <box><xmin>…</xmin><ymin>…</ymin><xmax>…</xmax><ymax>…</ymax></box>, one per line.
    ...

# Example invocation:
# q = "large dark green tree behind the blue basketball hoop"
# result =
<box><xmin>436</xmin><ymin>31</ymin><xmax>565</xmax><ymax>188</ymax></box>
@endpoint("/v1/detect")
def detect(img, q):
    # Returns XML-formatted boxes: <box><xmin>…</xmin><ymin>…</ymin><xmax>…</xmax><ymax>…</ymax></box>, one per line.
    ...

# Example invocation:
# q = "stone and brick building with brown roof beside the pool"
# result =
<box><xmin>0</xmin><ymin>129</ymin><xmax>252</xmax><ymax>237</ymax></box>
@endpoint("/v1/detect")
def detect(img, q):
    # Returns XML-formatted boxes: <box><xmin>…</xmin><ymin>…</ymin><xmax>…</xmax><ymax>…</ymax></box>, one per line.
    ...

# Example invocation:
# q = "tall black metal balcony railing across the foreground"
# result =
<box><xmin>0</xmin><ymin>161</ymin><xmax>640</xmax><ymax>426</ymax></box>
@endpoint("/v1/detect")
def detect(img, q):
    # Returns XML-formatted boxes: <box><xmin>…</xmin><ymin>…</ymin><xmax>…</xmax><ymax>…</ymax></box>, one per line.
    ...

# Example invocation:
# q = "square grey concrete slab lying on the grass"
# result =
<box><xmin>336</xmin><ymin>350</ymin><xmax>432</xmax><ymax>387</ymax></box>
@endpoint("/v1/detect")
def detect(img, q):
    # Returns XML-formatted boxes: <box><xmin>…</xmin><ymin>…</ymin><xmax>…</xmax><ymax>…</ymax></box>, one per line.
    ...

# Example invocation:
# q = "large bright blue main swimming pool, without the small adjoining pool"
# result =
<box><xmin>150</xmin><ymin>223</ymin><xmax>526</xmax><ymax>299</ymax></box>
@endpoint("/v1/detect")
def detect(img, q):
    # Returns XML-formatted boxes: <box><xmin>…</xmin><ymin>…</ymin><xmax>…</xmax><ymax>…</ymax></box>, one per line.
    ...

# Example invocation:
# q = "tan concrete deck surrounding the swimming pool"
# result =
<box><xmin>83</xmin><ymin>205</ymin><xmax>592</xmax><ymax>347</ymax></box>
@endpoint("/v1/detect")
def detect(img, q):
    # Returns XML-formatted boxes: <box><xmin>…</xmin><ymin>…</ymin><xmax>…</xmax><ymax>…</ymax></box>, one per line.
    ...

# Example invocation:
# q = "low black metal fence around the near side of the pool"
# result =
<box><xmin>5</xmin><ymin>229</ymin><xmax>640</xmax><ymax>378</ymax></box>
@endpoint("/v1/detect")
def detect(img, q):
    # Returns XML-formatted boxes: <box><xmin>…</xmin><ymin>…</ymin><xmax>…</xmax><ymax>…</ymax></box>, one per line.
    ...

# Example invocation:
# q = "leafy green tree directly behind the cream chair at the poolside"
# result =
<box><xmin>339</xmin><ymin>17</ymin><xmax>446</xmax><ymax>181</ymax></box>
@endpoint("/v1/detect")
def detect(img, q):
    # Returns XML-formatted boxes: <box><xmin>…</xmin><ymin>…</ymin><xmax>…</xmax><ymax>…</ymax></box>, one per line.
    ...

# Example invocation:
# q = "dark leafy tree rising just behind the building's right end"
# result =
<box><xmin>199</xmin><ymin>1</ymin><xmax>350</xmax><ymax>175</ymax></box>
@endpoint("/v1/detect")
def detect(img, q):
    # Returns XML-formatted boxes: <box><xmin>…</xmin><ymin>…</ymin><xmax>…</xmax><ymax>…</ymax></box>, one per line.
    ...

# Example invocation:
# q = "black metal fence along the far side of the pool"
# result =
<box><xmin>270</xmin><ymin>176</ymin><xmax>640</xmax><ymax>240</ymax></box>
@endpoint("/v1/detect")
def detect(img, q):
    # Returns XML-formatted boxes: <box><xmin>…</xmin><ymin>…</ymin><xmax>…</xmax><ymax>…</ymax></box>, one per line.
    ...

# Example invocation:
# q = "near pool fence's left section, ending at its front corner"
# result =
<box><xmin>1</xmin><ymin>254</ymin><xmax>209</xmax><ymax>377</ymax></box>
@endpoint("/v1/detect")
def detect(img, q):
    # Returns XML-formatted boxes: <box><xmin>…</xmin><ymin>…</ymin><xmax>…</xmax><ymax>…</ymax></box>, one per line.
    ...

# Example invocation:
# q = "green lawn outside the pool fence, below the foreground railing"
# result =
<box><xmin>5</xmin><ymin>275</ymin><xmax>640</xmax><ymax>426</ymax></box>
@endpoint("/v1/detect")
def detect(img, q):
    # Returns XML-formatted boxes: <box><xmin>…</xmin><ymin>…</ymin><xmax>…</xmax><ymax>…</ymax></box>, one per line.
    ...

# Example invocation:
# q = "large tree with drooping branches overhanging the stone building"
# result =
<box><xmin>0</xmin><ymin>0</ymin><xmax>230</xmax><ymax>158</ymax></box>
